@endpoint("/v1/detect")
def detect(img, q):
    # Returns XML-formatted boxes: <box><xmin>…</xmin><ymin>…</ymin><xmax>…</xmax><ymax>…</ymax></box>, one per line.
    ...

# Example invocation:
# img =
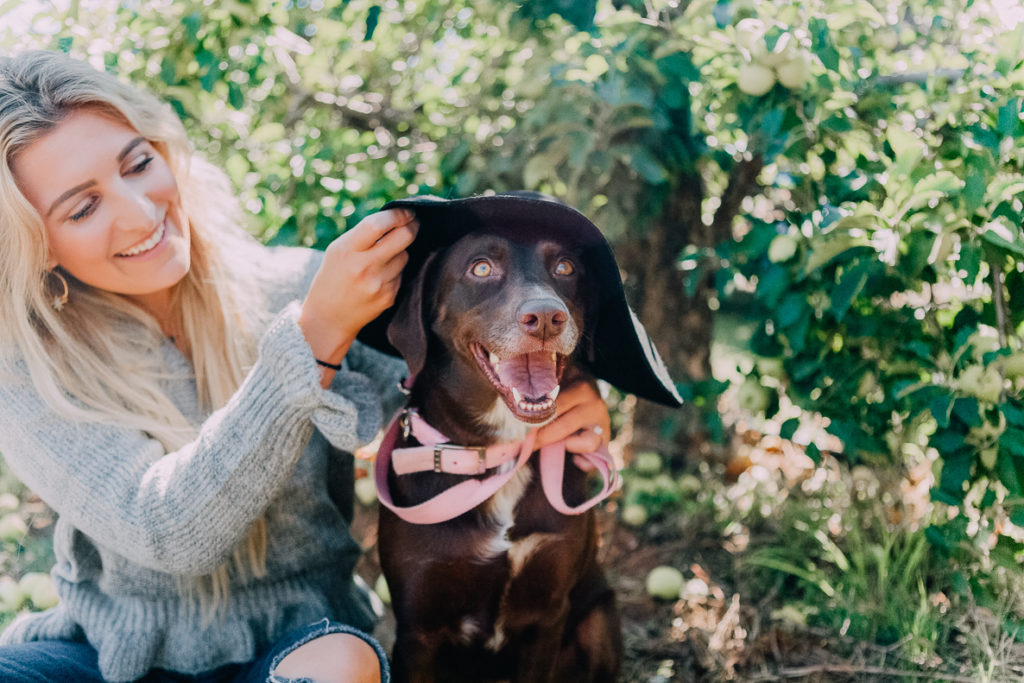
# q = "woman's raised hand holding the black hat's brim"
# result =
<box><xmin>299</xmin><ymin>209</ymin><xmax>420</xmax><ymax>384</ymax></box>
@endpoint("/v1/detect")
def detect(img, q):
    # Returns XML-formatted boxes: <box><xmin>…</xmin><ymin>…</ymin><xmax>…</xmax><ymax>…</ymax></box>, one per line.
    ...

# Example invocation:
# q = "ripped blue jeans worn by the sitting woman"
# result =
<box><xmin>0</xmin><ymin>620</ymin><xmax>391</xmax><ymax>683</ymax></box>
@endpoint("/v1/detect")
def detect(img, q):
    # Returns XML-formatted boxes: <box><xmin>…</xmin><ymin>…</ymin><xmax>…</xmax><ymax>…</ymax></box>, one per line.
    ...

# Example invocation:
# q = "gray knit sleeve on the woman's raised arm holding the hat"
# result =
<box><xmin>0</xmin><ymin>303</ymin><xmax>380</xmax><ymax>574</ymax></box>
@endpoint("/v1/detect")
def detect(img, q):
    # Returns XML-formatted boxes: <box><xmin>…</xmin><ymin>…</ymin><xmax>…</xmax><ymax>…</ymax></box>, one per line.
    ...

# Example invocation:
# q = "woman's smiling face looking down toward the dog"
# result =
<box><xmin>12</xmin><ymin>110</ymin><xmax>189</xmax><ymax>314</ymax></box>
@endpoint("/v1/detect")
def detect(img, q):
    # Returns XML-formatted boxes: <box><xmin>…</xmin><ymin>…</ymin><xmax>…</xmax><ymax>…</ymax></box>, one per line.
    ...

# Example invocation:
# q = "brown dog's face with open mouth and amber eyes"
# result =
<box><xmin>388</xmin><ymin>233</ymin><xmax>588</xmax><ymax>424</ymax></box>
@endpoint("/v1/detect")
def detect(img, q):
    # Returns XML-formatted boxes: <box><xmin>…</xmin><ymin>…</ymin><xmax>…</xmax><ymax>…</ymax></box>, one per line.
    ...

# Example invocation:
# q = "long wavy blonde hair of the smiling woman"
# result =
<box><xmin>0</xmin><ymin>51</ymin><xmax>266</xmax><ymax>607</ymax></box>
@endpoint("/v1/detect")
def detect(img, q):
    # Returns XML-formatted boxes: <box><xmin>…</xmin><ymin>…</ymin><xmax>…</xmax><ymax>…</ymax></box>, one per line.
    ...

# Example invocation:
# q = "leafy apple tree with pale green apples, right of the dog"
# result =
<box><xmin>445</xmin><ymin>0</ymin><xmax>1024</xmax><ymax>563</ymax></box>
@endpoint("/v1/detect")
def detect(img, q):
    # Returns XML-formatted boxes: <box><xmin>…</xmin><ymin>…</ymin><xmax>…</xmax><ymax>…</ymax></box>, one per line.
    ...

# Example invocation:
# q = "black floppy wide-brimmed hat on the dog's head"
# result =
<box><xmin>358</xmin><ymin>193</ymin><xmax>683</xmax><ymax>408</ymax></box>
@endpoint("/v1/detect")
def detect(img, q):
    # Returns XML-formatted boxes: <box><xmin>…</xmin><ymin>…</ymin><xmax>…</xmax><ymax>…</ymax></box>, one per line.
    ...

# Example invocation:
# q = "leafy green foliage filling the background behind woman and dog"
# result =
<box><xmin>6</xmin><ymin>0</ymin><xmax>1024</xmax><ymax>671</ymax></box>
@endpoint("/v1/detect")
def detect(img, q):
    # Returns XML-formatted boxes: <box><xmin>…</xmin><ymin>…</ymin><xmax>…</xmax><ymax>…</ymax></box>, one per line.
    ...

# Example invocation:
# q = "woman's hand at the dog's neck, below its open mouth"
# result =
<box><xmin>535</xmin><ymin>380</ymin><xmax>611</xmax><ymax>453</ymax></box>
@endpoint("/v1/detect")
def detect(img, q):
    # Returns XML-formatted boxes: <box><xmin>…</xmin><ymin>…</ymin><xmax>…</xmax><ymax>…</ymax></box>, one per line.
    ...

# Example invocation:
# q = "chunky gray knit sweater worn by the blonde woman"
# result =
<box><xmin>0</xmin><ymin>248</ymin><xmax>404</xmax><ymax>681</ymax></box>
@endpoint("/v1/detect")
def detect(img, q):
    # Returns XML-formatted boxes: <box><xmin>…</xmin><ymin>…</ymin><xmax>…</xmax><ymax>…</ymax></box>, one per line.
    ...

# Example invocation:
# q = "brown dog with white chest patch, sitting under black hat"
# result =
<box><xmin>379</xmin><ymin>231</ymin><xmax>623</xmax><ymax>683</ymax></box>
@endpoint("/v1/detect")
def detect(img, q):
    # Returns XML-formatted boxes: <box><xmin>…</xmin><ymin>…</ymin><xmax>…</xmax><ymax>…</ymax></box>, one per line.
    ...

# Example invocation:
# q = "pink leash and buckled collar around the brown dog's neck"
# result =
<box><xmin>374</xmin><ymin>411</ymin><xmax>620</xmax><ymax>524</ymax></box>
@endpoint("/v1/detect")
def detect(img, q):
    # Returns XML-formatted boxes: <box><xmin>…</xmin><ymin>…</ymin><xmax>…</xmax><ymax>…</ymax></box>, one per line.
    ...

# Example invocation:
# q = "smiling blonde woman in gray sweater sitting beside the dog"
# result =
<box><xmin>0</xmin><ymin>52</ymin><xmax>607</xmax><ymax>682</ymax></box>
